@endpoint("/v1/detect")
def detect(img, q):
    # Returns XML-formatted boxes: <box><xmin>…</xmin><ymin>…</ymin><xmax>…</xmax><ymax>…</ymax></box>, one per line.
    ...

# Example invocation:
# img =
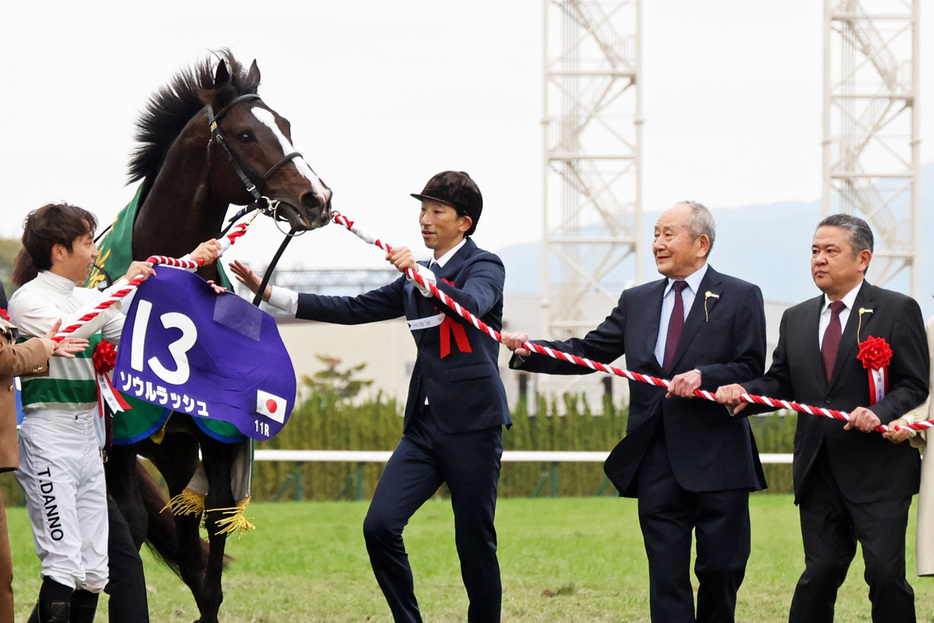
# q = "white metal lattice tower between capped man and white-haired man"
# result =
<box><xmin>542</xmin><ymin>0</ymin><xmax>642</xmax><ymax>338</ymax></box>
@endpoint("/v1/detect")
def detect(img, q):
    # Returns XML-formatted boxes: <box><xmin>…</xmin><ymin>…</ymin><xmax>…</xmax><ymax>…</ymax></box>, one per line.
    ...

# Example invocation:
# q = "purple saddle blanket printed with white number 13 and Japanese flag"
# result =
<box><xmin>114</xmin><ymin>268</ymin><xmax>296</xmax><ymax>440</ymax></box>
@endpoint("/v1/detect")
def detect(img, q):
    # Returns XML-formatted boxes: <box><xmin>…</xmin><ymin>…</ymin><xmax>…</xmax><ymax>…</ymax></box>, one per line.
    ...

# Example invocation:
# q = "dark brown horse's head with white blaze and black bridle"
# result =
<box><xmin>202</xmin><ymin>59</ymin><xmax>331</xmax><ymax>230</ymax></box>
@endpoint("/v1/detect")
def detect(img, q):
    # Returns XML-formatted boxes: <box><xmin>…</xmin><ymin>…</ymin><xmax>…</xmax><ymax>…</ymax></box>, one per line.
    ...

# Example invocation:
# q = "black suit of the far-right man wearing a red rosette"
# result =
<box><xmin>742</xmin><ymin>282</ymin><xmax>929</xmax><ymax>622</ymax></box>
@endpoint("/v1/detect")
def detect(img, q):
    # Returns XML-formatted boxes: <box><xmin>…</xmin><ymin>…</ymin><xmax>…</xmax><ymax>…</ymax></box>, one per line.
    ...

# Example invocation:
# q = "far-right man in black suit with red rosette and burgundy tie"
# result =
<box><xmin>717</xmin><ymin>214</ymin><xmax>929</xmax><ymax>623</ymax></box>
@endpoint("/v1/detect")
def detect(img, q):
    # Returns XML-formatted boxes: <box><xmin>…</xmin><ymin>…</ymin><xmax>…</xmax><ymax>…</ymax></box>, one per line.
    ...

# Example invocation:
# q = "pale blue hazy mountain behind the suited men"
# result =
<box><xmin>497</xmin><ymin>163</ymin><xmax>934</xmax><ymax>317</ymax></box>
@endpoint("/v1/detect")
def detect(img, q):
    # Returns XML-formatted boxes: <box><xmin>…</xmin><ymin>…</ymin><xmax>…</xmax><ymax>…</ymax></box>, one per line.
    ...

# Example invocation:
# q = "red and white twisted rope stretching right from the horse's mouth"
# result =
<box><xmin>331</xmin><ymin>212</ymin><xmax>934</xmax><ymax>432</ymax></box>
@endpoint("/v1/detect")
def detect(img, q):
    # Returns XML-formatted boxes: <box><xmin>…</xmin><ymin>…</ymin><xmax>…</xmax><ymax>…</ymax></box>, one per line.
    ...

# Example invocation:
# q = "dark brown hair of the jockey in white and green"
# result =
<box><xmin>13</xmin><ymin>203</ymin><xmax>97</xmax><ymax>286</ymax></box>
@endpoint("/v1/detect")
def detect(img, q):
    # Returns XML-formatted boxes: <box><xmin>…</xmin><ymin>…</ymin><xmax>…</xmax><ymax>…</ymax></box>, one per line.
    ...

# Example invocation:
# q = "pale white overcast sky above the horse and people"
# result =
<box><xmin>0</xmin><ymin>0</ymin><xmax>934</xmax><ymax>268</ymax></box>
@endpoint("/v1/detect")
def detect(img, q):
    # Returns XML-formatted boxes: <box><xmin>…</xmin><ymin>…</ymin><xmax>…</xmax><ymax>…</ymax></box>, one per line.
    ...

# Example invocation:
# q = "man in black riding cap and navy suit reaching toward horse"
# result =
<box><xmin>231</xmin><ymin>171</ymin><xmax>512</xmax><ymax>623</ymax></box>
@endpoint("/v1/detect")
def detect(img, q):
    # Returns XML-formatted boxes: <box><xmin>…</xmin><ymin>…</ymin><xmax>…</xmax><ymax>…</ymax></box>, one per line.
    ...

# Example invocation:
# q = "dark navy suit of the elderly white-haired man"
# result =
<box><xmin>511</xmin><ymin>268</ymin><xmax>765</xmax><ymax>621</ymax></box>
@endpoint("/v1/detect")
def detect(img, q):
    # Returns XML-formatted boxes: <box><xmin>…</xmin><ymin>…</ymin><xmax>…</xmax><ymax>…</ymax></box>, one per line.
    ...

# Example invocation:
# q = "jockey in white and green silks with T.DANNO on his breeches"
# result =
<box><xmin>10</xmin><ymin>204</ymin><xmax>217</xmax><ymax>623</ymax></box>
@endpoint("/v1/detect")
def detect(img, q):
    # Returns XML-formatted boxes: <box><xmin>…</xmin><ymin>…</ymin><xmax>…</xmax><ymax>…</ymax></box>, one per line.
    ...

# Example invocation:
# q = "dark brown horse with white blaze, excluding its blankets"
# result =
<box><xmin>99</xmin><ymin>50</ymin><xmax>331</xmax><ymax>623</ymax></box>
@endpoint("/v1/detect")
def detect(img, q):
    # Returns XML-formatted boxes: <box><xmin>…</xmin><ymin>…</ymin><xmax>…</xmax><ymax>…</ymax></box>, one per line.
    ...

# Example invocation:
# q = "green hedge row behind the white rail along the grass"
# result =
<box><xmin>0</xmin><ymin>392</ymin><xmax>796</xmax><ymax>505</ymax></box>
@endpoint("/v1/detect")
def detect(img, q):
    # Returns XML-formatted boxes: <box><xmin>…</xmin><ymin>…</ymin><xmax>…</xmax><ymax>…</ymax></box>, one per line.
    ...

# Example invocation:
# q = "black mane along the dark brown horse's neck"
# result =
<box><xmin>129</xmin><ymin>48</ymin><xmax>259</xmax><ymax>205</ymax></box>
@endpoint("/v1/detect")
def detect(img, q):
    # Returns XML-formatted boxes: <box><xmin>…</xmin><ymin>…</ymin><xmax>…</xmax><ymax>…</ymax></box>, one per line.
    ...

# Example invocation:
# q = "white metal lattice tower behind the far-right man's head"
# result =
<box><xmin>823</xmin><ymin>0</ymin><xmax>921</xmax><ymax>298</ymax></box>
